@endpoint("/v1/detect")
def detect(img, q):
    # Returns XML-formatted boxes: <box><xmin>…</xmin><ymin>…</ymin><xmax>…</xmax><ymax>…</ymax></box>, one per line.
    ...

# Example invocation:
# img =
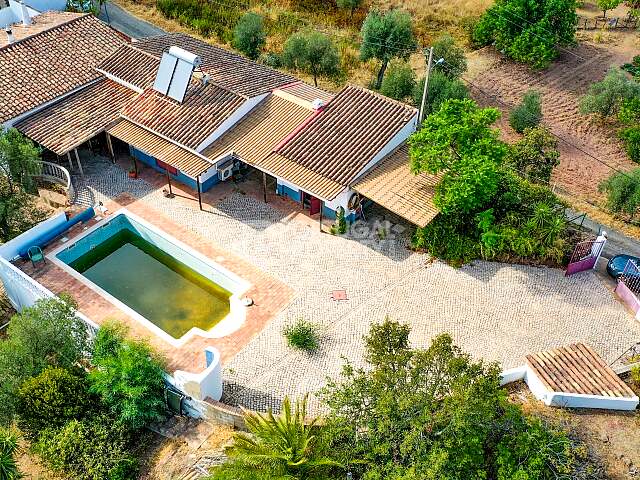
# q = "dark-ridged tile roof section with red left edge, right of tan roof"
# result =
<box><xmin>276</xmin><ymin>86</ymin><xmax>417</xmax><ymax>185</ymax></box>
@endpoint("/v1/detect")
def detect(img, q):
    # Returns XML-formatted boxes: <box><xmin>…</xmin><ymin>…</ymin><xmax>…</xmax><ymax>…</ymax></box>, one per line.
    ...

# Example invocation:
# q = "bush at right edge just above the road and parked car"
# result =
<box><xmin>598</xmin><ymin>168</ymin><xmax>640</xmax><ymax>222</ymax></box>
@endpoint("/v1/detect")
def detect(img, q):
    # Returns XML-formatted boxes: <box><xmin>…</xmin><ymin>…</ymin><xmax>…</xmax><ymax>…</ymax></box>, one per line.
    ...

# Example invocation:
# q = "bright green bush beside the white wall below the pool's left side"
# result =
<box><xmin>89</xmin><ymin>323</ymin><xmax>166</xmax><ymax>430</ymax></box>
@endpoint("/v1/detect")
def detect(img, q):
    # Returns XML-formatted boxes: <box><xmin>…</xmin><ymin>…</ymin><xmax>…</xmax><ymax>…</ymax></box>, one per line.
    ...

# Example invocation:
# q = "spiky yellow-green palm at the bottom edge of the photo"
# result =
<box><xmin>211</xmin><ymin>396</ymin><xmax>340</xmax><ymax>480</ymax></box>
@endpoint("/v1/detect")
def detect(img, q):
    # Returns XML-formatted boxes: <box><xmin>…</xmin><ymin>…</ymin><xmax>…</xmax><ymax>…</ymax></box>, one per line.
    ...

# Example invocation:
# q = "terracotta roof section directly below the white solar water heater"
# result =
<box><xmin>122</xmin><ymin>78</ymin><xmax>246</xmax><ymax>150</ymax></box>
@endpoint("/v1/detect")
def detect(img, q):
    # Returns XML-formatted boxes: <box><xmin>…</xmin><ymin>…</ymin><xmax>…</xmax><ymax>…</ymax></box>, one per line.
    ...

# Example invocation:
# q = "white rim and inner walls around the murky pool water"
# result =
<box><xmin>47</xmin><ymin>208</ymin><xmax>251</xmax><ymax>347</ymax></box>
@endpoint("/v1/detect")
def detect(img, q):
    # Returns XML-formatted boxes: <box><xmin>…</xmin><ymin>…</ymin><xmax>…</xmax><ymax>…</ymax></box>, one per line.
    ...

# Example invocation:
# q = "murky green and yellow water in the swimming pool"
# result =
<box><xmin>70</xmin><ymin>229</ymin><xmax>231</xmax><ymax>338</ymax></box>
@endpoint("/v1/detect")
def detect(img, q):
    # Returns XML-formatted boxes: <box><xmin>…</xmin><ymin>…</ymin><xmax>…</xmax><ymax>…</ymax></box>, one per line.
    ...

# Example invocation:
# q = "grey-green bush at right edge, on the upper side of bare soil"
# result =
<box><xmin>580</xmin><ymin>67</ymin><xmax>640</xmax><ymax>118</ymax></box>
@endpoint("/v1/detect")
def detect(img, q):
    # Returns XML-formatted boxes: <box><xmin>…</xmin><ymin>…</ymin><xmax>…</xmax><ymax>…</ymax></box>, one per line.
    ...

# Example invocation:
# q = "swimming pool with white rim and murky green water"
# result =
<box><xmin>52</xmin><ymin>210</ymin><xmax>249</xmax><ymax>344</ymax></box>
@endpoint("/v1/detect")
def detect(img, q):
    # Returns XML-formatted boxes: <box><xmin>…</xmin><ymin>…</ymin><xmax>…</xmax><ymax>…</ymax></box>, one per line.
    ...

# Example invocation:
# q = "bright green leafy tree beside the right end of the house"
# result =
<box><xmin>409</xmin><ymin>100</ymin><xmax>507</xmax><ymax>213</ymax></box>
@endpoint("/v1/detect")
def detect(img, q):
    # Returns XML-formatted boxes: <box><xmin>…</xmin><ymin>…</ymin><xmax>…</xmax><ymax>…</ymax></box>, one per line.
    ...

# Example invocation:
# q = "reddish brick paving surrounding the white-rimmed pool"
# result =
<box><xmin>16</xmin><ymin>194</ymin><xmax>293</xmax><ymax>372</ymax></box>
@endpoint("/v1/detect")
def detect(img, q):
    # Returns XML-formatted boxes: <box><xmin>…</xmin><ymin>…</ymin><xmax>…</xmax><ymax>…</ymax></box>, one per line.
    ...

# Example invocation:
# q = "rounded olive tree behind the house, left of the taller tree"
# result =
<box><xmin>281</xmin><ymin>31</ymin><xmax>340</xmax><ymax>87</ymax></box>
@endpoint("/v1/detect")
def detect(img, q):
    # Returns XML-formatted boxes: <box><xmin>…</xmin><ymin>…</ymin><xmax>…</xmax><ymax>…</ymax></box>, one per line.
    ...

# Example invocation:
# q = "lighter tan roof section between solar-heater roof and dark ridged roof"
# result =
<box><xmin>202</xmin><ymin>91</ymin><xmax>313</xmax><ymax>164</ymax></box>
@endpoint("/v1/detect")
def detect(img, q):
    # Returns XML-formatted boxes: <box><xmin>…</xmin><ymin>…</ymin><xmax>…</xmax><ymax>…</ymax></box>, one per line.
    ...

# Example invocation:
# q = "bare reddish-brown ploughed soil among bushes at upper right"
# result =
<box><xmin>472</xmin><ymin>33</ymin><xmax>637</xmax><ymax>200</ymax></box>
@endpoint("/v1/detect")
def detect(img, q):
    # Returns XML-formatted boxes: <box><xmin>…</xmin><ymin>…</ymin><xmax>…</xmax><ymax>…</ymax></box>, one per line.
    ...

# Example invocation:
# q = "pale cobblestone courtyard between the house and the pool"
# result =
<box><xmin>69</xmin><ymin>157</ymin><xmax>640</xmax><ymax>409</ymax></box>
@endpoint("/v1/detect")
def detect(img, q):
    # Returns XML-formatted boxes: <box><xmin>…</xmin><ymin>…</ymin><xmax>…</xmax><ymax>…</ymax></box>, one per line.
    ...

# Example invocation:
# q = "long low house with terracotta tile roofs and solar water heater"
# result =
<box><xmin>0</xmin><ymin>13</ymin><xmax>437</xmax><ymax>226</ymax></box>
